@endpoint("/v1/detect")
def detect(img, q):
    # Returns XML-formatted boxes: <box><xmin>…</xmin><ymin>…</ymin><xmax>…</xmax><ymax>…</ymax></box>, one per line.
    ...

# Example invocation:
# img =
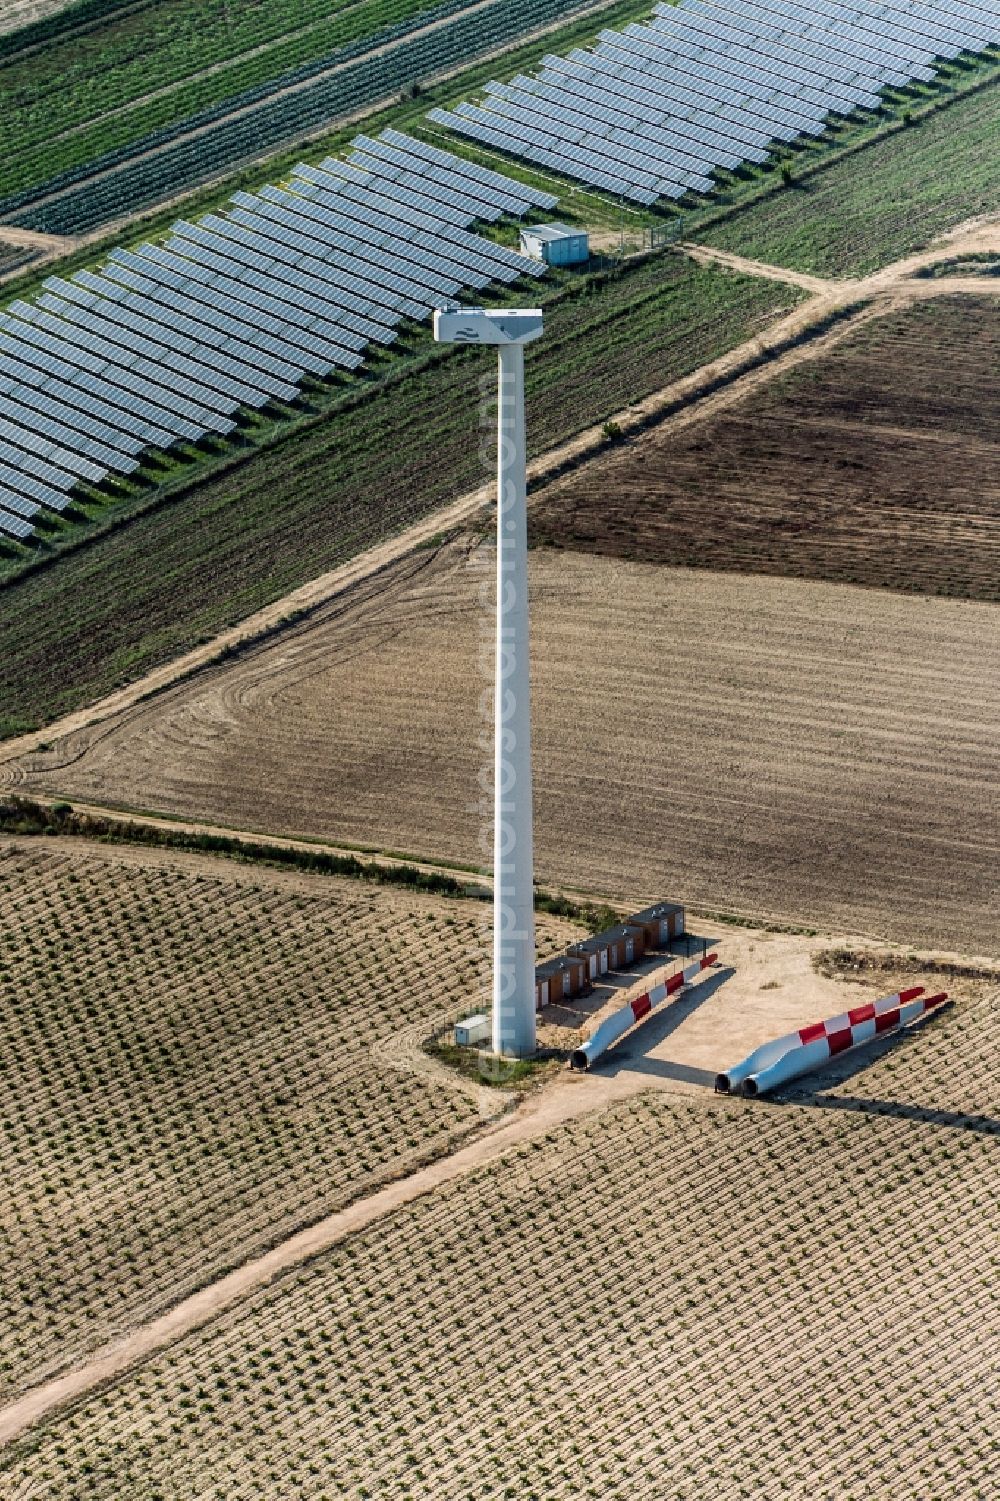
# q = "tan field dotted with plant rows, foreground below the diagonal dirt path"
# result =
<box><xmin>0</xmin><ymin>1093</ymin><xmax>1000</xmax><ymax>1501</ymax></box>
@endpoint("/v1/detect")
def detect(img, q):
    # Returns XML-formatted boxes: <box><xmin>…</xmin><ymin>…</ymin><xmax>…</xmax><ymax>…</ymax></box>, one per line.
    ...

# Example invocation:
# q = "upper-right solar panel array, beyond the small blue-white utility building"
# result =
<box><xmin>429</xmin><ymin>0</ymin><xmax>1000</xmax><ymax>206</ymax></box>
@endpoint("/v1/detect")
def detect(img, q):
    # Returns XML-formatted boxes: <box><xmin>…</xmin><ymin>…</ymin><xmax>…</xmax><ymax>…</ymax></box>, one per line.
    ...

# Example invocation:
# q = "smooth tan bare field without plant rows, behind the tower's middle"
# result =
<box><xmin>17</xmin><ymin>539</ymin><xmax>1000</xmax><ymax>955</ymax></box>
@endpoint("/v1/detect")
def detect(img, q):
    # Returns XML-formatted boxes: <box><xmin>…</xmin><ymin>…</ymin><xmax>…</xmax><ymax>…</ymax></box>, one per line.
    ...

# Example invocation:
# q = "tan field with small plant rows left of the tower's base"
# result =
<box><xmin>0</xmin><ymin>839</ymin><xmax>580</xmax><ymax>1398</ymax></box>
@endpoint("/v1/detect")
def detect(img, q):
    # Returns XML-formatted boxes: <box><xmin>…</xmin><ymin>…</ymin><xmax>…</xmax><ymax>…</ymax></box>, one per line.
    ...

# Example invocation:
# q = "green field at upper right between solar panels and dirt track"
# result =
<box><xmin>700</xmin><ymin>60</ymin><xmax>1000</xmax><ymax>276</ymax></box>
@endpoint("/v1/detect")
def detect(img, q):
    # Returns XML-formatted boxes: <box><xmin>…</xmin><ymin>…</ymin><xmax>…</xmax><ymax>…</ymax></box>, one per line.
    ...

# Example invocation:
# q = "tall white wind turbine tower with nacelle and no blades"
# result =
<box><xmin>434</xmin><ymin>308</ymin><xmax>542</xmax><ymax>1058</ymax></box>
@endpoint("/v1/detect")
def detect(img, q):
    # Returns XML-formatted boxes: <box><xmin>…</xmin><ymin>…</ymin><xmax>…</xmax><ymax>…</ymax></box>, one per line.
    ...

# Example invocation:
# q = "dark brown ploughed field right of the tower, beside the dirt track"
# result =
<box><xmin>532</xmin><ymin>297</ymin><xmax>1000</xmax><ymax>600</ymax></box>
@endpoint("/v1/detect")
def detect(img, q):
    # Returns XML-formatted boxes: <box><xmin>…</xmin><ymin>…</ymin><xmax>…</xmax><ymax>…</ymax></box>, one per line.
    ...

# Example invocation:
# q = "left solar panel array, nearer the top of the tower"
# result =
<box><xmin>0</xmin><ymin>131</ymin><xmax>556</xmax><ymax>539</ymax></box>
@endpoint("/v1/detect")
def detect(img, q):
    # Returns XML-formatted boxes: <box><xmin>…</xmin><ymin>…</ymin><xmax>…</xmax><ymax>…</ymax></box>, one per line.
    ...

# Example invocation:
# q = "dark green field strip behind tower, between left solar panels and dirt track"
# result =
<box><xmin>0</xmin><ymin>257</ymin><xmax>797</xmax><ymax>735</ymax></box>
